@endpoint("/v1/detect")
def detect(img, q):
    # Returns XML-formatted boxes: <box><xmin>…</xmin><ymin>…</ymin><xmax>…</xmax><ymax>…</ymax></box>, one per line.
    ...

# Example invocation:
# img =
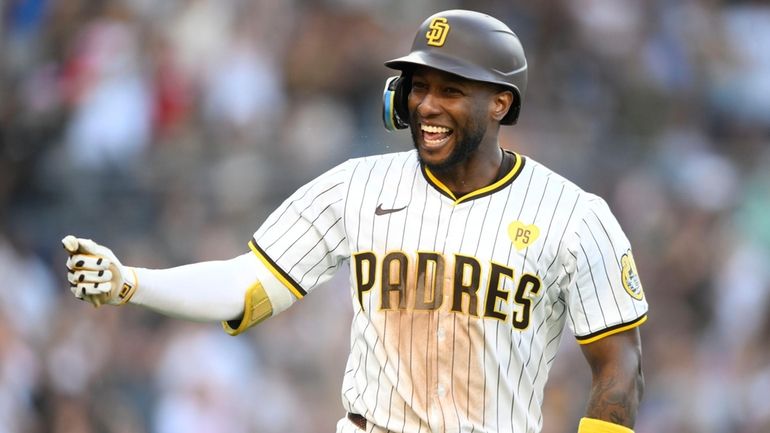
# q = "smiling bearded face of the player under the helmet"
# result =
<box><xmin>408</xmin><ymin>67</ymin><xmax>512</xmax><ymax>171</ymax></box>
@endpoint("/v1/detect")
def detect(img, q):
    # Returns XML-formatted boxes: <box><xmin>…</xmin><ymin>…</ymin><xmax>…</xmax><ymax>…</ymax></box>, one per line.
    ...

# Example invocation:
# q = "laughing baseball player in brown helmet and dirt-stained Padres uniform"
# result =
<box><xmin>63</xmin><ymin>10</ymin><xmax>647</xmax><ymax>433</ymax></box>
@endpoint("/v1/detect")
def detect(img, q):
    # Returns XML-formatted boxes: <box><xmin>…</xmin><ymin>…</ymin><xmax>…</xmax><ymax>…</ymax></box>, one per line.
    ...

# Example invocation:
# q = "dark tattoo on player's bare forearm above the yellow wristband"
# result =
<box><xmin>586</xmin><ymin>377</ymin><xmax>639</xmax><ymax>427</ymax></box>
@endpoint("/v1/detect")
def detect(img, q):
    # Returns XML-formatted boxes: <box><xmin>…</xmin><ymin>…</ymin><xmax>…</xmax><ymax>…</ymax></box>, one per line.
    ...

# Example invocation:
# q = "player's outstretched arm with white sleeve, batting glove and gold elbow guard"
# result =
<box><xmin>62</xmin><ymin>236</ymin><xmax>293</xmax><ymax>335</ymax></box>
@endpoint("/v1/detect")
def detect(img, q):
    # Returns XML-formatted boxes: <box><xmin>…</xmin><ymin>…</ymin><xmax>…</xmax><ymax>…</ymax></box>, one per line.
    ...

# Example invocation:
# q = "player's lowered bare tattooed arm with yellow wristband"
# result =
<box><xmin>579</xmin><ymin>328</ymin><xmax>644</xmax><ymax>433</ymax></box>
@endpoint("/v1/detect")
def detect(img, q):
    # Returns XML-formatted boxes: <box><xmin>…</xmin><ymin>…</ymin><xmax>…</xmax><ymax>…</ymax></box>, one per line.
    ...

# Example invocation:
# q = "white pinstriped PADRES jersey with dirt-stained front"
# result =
<box><xmin>250</xmin><ymin>151</ymin><xmax>647</xmax><ymax>433</ymax></box>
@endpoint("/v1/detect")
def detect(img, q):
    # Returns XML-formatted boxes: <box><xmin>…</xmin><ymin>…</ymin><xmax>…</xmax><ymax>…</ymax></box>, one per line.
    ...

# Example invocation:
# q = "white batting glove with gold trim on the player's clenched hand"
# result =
<box><xmin>62</xmin><ymin>235</ymin><xmax>137</xmax><ymax>307</ymax></box>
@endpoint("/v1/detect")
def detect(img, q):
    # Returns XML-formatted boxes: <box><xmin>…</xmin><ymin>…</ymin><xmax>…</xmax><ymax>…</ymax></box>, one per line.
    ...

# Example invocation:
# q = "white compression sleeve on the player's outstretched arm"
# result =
<box><xmin>130</xmin><ymin>252</ymin><xmax>292</xmax><ymax>322</ymax></box>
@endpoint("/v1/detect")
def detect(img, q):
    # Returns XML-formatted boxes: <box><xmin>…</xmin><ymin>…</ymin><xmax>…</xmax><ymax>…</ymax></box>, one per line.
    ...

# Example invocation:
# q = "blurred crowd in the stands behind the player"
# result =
<box><xmin>0</xmin><ymin>0</ymin><xmax>770</xmax><ymax>433</ymax></box>
